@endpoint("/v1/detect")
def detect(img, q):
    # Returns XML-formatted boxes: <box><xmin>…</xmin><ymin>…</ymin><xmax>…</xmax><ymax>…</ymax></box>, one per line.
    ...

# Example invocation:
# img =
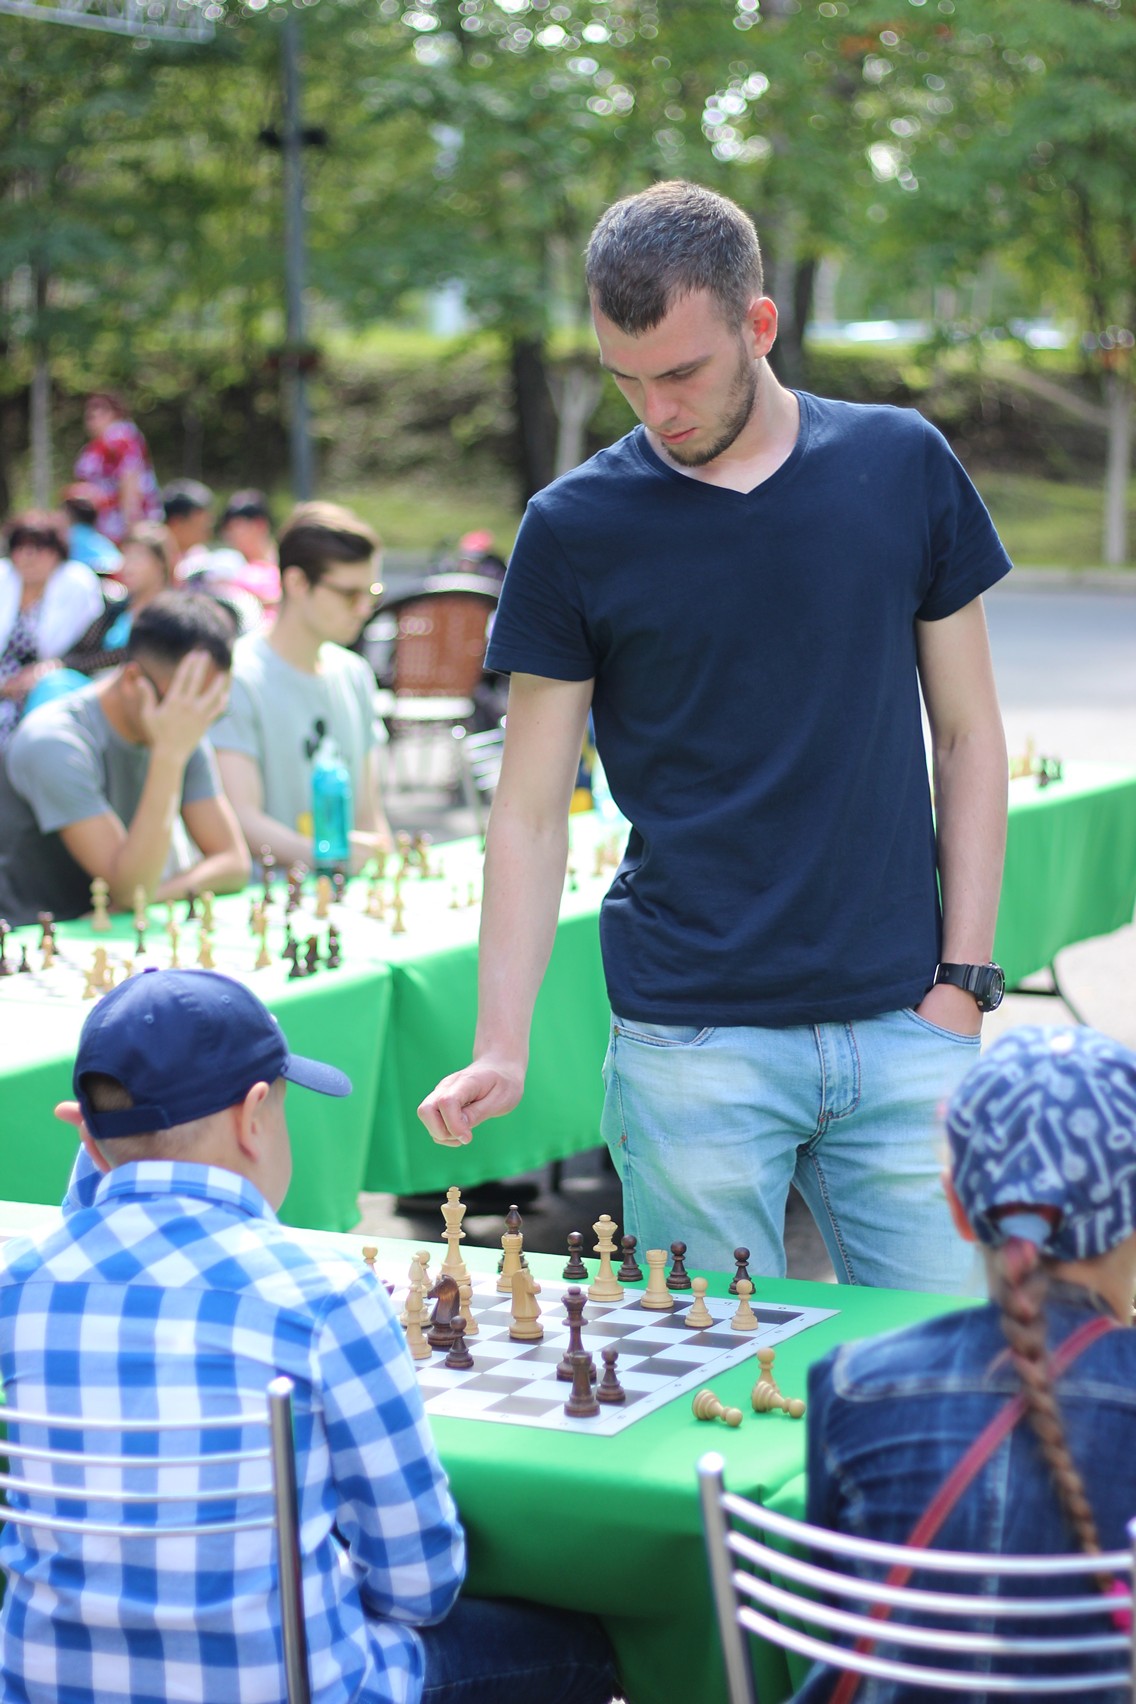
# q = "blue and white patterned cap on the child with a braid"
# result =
<box><xmin>947</xmin><ymin>1026</ymin><xmax>1136</xmax><ymax>1261</ymax></box>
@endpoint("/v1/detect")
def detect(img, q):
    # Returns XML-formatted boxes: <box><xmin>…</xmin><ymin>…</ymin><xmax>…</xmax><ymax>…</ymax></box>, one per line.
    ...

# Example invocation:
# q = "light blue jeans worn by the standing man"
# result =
<box><xmin>603</xmin><ymin>1010</ymin><xmax>979</xmax><ymax>1293</ymax></box>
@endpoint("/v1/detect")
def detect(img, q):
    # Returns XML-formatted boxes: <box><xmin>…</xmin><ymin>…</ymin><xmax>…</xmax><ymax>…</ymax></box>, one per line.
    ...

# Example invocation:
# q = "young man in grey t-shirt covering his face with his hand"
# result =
<box><xmin>0</xmin><ymin>591</ymin><xmax>249</xmax><ymax>924</ymax></box>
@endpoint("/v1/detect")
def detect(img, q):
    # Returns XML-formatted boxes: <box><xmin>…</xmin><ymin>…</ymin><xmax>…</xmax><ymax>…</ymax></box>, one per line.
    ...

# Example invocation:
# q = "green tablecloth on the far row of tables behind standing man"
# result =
<box><xmin>0</xmin><ymin>763</ymin><xmax>1136</xmax><ymax>1229</ymax></box>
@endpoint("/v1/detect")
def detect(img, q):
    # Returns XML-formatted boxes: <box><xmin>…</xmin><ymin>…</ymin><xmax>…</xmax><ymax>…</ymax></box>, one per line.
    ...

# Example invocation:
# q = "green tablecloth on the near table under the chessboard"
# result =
<box><xmin>0</xmin><ymin>1203</ymin><xmax>957</xmax><ymax>1704</ymax></box>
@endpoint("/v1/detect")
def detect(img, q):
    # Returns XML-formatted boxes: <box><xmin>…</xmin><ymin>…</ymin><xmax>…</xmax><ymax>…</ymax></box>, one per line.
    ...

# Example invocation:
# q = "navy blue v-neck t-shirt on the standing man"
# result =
<box><xmin>487</xmin><ymin>394</ymin><xmax>1010</xmax><ymax>1026</ymax></box>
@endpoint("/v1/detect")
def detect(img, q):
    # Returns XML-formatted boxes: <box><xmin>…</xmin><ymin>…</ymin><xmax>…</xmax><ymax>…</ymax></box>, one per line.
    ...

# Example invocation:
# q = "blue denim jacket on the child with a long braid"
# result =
<box><xmin>799</xmin><ymin>1281</ymin><xmax>1136</xmax><ymax>1704</ymax></box>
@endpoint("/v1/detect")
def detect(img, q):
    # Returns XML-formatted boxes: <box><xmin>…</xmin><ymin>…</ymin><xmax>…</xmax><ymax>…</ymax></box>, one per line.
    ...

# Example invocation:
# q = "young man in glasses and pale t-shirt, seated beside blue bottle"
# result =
<box><xmin>213</xmin><ymin>503</ymin><xmax>390</xmax><ymax>871</ymax></box>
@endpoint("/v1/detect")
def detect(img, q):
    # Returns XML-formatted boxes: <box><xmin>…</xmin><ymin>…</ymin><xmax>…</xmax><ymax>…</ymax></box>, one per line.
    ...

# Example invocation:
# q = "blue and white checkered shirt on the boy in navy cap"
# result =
<box><xmin>0</xmin><ymin>1160</ymin><xmax>465</xmax><ymax>1704</ymax></box>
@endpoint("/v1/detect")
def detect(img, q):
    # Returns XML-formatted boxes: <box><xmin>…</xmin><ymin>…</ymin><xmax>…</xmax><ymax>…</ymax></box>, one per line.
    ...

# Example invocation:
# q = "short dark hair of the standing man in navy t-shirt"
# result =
<box><xmin>584</xmin><ymin>179</ymin><xmax>763</xmax><ymax>337</ymax></box>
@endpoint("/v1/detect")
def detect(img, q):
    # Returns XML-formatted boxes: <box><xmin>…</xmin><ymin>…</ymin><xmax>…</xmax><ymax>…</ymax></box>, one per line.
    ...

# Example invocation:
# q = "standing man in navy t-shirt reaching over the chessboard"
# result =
<box><xmin>421</xmin><ymin>182</ymin><xmax>1010</xmax><ymax>1290</ymax></box>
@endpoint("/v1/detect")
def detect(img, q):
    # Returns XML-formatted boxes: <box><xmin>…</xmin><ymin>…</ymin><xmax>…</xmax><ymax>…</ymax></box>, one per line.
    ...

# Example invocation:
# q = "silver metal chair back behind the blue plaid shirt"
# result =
<box><xmin>0</xmin><ymin>1377</ymin><xmax>312</xmax><ymax>1704</ymax></box>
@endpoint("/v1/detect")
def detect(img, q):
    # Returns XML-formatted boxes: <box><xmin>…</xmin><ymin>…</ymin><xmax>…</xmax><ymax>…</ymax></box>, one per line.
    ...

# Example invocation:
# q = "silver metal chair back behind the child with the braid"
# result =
<box><xmin>698</xmin><ymin>1452</ymin><xmax>1136</xmax><ymax>1704</ymax></box>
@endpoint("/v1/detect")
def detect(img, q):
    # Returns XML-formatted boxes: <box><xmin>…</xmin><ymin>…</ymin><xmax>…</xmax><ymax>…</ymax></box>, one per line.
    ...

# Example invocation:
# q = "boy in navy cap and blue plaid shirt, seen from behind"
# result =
<box><xmin>0</xmin><ymin>970</ymin><xmax>615</xmax><ymax>1704</ymax></box>
